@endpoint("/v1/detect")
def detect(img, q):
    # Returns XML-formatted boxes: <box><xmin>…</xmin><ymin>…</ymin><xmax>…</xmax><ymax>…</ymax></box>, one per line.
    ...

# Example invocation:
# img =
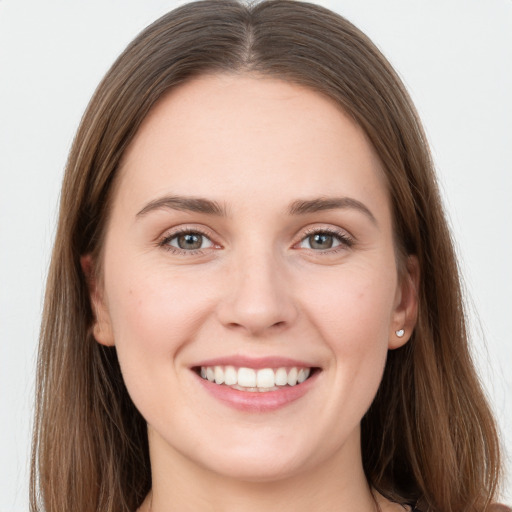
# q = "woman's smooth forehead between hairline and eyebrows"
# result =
<box><xmin>118</xmin><ymin>74</ymin><xmax>387</xmax><ymax>214</ymax></box>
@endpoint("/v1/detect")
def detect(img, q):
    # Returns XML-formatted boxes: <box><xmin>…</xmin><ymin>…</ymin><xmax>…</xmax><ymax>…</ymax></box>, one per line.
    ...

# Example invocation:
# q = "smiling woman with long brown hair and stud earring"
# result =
<box><xmin>32</xmin><ymin>0</ymin><xmax>506</xmax><ymax>512</ymax></box>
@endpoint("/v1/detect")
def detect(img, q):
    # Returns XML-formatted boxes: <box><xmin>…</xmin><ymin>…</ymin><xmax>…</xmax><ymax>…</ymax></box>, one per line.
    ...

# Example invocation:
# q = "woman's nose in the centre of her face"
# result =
<box><xmin>218</xmin><ymin>252</ymin><xmax>297</xmax><ymax>336</ymax></box>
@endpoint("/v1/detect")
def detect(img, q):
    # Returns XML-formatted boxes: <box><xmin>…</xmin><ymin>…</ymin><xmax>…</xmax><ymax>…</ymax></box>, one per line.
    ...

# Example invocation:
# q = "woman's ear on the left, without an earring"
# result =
<box><xmin>80</xmin><ymin>254</ymin><xmax>114</xmax><ymax>346</ymax></box>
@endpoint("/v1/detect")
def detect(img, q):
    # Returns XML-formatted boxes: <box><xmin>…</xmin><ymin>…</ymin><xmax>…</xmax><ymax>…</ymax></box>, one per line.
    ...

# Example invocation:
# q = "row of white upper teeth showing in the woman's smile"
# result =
<box><xmin>194</xmin><ymin>365</ymin><xmax>319</xmax><ymax>392</ymax></box>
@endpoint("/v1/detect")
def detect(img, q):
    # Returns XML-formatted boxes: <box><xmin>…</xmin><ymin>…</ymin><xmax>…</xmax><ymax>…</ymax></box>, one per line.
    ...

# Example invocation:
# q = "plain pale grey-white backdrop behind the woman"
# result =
<box><xmin>0</xmin><ymin>0</ymin><xmax>512</xmax><ymax>512</ymax></box>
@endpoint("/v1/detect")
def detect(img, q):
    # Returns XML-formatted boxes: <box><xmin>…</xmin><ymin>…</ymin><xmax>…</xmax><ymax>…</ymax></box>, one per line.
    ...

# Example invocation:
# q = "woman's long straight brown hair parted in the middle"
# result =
<box><xmin>31</xmin><ymin>0</ymin><xmax>500</xmax><ymax>512</ymax></box>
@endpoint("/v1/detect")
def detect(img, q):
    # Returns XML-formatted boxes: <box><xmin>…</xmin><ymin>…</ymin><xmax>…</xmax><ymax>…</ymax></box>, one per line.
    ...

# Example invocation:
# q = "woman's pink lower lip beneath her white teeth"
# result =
<box><xmin>195</xmin><ymin>371</ymin><xmax>320</xmax><ymax>412</ymax></box>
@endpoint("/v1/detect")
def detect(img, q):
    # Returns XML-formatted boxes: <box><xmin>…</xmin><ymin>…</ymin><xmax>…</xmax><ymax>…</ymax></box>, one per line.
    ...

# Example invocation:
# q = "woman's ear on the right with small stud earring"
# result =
<box><xmin>388</xmin><ymin>256</ymin><xmax>420</xmax><ymax>350</ymax></box>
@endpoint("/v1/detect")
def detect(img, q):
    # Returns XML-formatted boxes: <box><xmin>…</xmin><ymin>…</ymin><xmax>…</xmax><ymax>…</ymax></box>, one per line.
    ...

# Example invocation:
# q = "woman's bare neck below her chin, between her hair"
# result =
<box><xmin>141</xmin><ymin>426</ymin><xmax>376</xmax><ymax>512</ymax></box>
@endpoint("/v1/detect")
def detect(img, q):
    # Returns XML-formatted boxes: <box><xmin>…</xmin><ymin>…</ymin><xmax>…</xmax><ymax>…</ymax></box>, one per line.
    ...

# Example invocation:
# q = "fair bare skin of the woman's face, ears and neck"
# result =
<box><xmin>82</xmin><ymin>75</ymin><xmax>417</xmax><ymax>512</ymax></box>
